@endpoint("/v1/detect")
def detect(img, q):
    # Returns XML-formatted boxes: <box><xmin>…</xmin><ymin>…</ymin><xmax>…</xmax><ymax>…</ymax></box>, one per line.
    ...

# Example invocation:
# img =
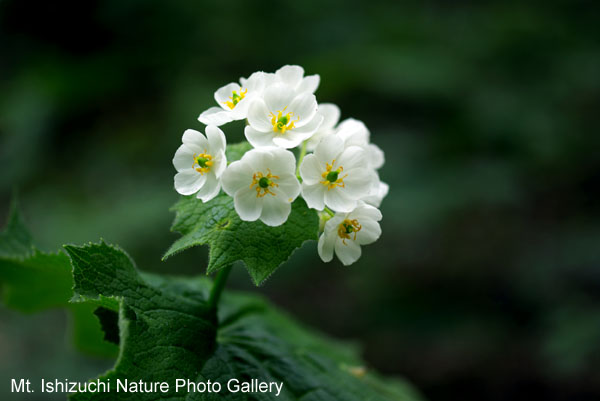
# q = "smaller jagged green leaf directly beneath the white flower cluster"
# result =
<box><xmin>163</xmin><ymin>142</ymin><xmax>319</xmax><ymax>285</ymax></box>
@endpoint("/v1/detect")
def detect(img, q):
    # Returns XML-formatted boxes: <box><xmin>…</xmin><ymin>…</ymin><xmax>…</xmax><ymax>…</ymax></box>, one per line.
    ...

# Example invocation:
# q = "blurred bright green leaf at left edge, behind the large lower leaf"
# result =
<box><xmin>0</xmin><ymin>202</ymin><xmax>117</xmax><ymax>356</ymax></box>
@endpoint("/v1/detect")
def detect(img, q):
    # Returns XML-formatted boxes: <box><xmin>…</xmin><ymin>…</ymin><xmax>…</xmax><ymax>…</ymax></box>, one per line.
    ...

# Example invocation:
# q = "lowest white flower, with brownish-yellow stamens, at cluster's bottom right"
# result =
<box><xmin>318</xmin><ymin>202</ymin><xmax>381</xmax><ymax>266</ymax></box>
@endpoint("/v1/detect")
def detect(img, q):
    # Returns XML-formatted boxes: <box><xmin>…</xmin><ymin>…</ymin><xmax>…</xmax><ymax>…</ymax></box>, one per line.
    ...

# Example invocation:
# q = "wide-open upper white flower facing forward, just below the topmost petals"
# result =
<box><xmin>244</xmin><ymin>83</ymin><xmax>323</xmax><ymax>148</ymax></box>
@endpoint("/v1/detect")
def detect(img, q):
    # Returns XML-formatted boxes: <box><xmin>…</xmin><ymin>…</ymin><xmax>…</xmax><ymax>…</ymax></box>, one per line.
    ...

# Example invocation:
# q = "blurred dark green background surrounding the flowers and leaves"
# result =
<box><xmin>0</xmin><ymin>0</ymin><xmax>600</xmax><ymax>401</ymax></box>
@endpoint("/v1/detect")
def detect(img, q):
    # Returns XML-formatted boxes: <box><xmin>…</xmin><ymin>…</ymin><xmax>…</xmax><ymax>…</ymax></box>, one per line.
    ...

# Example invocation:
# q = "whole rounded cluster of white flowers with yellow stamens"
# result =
<box><xmin>173</xmin><ymin>65</ymin><xmax>389</xmax><ymax>265</ymax></box>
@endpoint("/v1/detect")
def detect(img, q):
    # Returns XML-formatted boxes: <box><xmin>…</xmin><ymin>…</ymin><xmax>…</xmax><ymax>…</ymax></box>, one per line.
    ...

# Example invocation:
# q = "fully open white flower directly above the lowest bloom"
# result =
<box><xmin>300</xmin><ymin>135</ymin><xmax>377</xmax><ymax>212</ymax></box>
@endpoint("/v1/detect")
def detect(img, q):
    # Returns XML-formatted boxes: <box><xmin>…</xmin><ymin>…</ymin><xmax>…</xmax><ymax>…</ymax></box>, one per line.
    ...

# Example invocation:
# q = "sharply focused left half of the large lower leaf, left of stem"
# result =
<box><xmin>65</xmin><ymin>242</ymin><xmax>217</xmax><ymax>400</ymax></box>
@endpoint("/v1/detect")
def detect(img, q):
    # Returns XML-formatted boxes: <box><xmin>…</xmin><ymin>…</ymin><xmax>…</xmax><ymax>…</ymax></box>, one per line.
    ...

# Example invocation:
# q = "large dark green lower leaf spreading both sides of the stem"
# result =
<box><xmin>66</xmin><ymin>239</ymin><xmax>419</xmax><ymax>401</ymax></box>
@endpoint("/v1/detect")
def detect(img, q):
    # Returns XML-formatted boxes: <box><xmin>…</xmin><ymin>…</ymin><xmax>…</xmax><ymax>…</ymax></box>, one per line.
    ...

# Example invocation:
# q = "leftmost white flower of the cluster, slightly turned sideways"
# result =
<box><xmin>173</xmin><ymin>125</ymin><xmax>227</xmax><ymax>202</ymax></box>
